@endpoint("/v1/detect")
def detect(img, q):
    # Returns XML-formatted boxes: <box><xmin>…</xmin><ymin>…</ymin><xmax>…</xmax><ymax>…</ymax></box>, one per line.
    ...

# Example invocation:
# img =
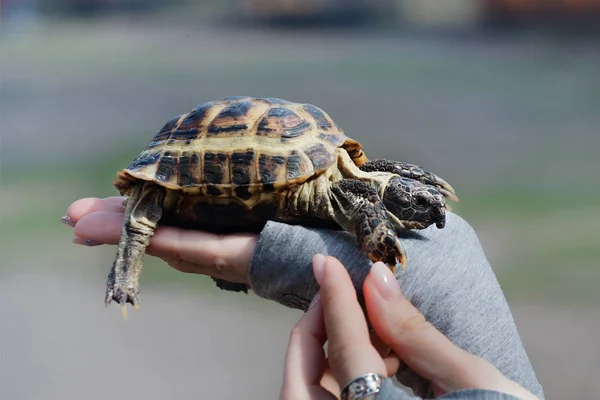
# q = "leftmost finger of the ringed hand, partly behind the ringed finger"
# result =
<box><xmin>281</xmin><ymin>295</ymin><xmax>335</xmax><ymax>400</ymax></box>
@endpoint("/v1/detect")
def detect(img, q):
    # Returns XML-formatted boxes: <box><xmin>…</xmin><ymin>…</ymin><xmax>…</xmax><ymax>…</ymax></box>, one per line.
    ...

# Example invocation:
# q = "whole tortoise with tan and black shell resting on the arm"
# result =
<box><xmin>105</xmin><ymin>96</ymin><xmax>458</xmax><ymax>312</ymax></box>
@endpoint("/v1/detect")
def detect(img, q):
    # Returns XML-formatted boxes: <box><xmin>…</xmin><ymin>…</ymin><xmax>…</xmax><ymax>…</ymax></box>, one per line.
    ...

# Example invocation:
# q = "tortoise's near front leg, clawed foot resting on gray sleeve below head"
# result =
<box><xmin>331</xmin><ymin>179</ymin><xmax>406</xmax><ymax>273</ymax></box>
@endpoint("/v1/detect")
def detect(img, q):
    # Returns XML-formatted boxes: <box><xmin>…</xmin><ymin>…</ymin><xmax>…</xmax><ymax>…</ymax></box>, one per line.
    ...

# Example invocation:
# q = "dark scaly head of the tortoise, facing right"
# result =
<box><xmin>383</xmin><ymin>176</ymin><xmax>446</xmax><ymax>229</ymax></box>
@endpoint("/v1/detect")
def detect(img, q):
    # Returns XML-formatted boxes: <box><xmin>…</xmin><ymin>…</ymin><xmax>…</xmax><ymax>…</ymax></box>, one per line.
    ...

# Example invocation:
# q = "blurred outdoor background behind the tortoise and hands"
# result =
<box><xmin>0</xmin><ymin>0</ymin><xmax>600</xmax><ymax>400</ymax></box>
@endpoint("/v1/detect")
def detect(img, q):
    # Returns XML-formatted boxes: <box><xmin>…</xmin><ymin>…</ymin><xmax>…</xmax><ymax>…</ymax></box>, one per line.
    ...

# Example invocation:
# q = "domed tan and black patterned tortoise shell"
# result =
<box><xmin>114</xmin><ymin>97</ymin><xmax>368</xmax><ymax>200</ymax></box>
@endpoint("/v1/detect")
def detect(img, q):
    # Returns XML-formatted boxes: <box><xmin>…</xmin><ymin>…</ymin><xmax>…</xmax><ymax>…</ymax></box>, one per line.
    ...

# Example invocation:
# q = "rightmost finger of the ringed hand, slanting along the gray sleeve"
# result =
<box><xmin>363</xmin><ymin>262</ymin><xmax>533</xmax><ymax>398</ymax></box>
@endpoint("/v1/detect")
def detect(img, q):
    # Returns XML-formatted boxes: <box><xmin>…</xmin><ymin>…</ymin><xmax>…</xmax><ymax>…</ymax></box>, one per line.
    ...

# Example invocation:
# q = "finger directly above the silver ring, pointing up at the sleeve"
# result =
<box><xmin>313</xmin><ymin>255</ymin><xmax>387</xmax><ymax>388</ymax></box>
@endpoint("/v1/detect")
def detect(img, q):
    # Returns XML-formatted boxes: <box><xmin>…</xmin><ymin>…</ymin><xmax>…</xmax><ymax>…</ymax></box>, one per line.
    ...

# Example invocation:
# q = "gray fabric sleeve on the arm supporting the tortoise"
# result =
<box><xmin>249</xmin><ymin>213</ymin><xmax>543</xmax><ymax>399</ymax></box>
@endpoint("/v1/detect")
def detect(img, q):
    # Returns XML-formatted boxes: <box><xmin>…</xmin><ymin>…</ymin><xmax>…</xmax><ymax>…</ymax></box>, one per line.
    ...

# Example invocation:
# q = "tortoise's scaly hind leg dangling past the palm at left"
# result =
<box><xmin>104</xmin><ymin>183</ymin><xmax>165</xmax><ymax>317</ymax></box>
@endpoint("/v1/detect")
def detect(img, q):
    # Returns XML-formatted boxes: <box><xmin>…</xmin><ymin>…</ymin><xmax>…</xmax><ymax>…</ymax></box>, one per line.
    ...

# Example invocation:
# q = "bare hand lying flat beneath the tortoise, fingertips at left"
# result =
<box><xmin>63</xmin><ymin>197</ymin><xmax>258</xmax><ymax>284</ymax></box>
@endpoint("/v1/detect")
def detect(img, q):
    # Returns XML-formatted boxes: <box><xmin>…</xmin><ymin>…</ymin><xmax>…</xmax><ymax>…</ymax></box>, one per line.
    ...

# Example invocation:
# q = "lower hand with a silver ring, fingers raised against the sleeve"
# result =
<box><xmin>281</xmin><ymin>255</ymin><xmax>537</xmax><ymax>400</ymax></box>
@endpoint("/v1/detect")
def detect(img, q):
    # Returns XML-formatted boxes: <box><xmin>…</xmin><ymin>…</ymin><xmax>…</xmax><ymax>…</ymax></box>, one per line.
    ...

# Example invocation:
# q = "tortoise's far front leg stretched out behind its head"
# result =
<box><xmin>359</xmin><ymin>160</ymin><xmax>458</xmax><ymax>201</ymax></box>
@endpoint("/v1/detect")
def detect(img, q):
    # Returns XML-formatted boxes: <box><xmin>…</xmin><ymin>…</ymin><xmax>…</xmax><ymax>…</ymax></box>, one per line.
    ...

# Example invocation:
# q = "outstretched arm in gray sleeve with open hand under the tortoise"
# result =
<box><xmin>66</xmin><ymin>198</ymin><xmax>543</xmax><ymax>398</ymax></box>
